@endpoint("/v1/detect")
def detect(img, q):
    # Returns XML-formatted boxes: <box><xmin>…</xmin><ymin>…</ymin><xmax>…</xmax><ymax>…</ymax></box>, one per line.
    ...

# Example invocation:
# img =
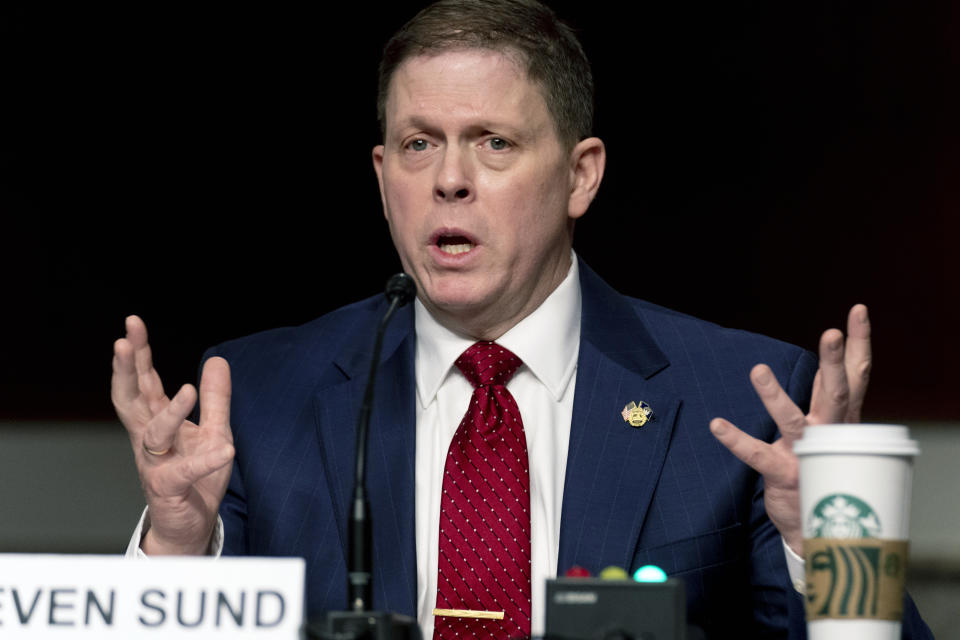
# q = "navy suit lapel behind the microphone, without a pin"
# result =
<box><xmin>314</xmin><ymin>305</ymin><xmax>417</xmax><ymax>615</ymax></box>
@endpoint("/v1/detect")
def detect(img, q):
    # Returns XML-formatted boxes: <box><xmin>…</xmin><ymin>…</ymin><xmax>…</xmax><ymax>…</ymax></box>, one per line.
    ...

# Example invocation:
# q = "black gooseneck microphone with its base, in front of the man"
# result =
<box><xmin>307</xmin><ymin>273</ymin><xmax>420</xmax><ymax>640</ymax></box>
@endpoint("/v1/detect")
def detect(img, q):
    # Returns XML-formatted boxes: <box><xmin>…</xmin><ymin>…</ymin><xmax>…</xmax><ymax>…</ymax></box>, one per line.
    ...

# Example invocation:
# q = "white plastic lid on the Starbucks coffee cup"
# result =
<box><xmin>793</xmin><ymin>424</ymin><xmax>920</xmax><ymax>456</ymax></box>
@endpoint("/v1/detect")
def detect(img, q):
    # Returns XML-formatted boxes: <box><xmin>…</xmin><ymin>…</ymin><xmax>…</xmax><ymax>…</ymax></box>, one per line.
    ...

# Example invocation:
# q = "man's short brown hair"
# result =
<box><xmin>377</xmin><ymin>0</ymin><xmax>593</xmax><ymax>147</ymax></box>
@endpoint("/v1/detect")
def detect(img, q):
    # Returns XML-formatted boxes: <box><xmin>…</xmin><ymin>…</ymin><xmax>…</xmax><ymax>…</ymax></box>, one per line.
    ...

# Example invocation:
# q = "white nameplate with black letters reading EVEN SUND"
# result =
<box><xmin>0</xmin><ymin>554</ymin><xmax>304</xmax><ymax>640</ymax></box>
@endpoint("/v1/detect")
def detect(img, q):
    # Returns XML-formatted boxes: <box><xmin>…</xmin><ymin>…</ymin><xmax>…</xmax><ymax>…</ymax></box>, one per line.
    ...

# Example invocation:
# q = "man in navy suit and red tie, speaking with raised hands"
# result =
<box><xmin>113</xmin><ymin>0</ymin><xmax>922</xmax><ymax>637</ymax></box>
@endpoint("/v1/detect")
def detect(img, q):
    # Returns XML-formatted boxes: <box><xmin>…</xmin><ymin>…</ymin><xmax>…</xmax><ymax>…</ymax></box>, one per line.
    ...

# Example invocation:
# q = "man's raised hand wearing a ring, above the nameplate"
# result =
<box><xmin>111</xmin><ymin>316</ymin><xmax>233</xmax><ymax>555</ymax></box>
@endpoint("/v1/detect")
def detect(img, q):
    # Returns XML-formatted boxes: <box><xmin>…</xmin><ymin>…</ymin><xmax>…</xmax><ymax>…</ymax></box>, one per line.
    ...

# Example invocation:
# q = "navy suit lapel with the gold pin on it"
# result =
<box><xmin>557</xmin><ymin>262</ymin><xmax>680</xmax><ymax>575</ymax></box>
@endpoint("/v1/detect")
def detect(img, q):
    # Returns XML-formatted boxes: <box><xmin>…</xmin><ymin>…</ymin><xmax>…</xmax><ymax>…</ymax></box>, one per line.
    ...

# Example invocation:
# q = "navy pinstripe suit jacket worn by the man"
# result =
<box><xmin>209</xmin><ymin>262</ymin><xmax>928</xmax><ymax>637</ymax></box>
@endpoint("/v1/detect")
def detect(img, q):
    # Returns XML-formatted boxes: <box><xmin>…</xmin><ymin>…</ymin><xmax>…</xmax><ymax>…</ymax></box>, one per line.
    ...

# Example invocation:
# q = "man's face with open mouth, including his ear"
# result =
<box><xmin>373</xmin><ymin>50</ymin><xmax>603</xmax><ymax>339</ymax></box>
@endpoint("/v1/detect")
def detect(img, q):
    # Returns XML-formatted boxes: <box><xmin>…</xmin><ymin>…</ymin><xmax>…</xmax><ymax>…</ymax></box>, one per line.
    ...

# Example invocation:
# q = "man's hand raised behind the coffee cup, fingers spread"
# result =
<box><xmin>710</xmin><ymin>304</ymin><xmax>870</xmax><ymax>555</ymax></box>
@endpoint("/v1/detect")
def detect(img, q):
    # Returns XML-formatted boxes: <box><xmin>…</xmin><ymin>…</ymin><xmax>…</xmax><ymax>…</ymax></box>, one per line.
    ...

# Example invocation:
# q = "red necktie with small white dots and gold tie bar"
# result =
<box><xmin>433</xmin><ymin>342</ymin><xmax>530</xmax><ymax>640</ymax></box>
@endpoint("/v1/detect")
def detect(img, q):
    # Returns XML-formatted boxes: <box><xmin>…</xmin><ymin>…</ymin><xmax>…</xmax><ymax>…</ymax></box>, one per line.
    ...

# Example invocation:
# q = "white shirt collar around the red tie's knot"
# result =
<box><xmin>415</xmin><ymin>251</ymin><xmax>580</xmax><ymax>407</ymax></box>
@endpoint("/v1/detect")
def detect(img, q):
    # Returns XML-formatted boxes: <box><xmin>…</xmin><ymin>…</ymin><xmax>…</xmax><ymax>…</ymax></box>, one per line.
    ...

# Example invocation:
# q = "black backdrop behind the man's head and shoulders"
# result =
<box><xmin>0</xmin><ymin>0</ymin><xmax>960</xmax><ymax>420</ymax></box>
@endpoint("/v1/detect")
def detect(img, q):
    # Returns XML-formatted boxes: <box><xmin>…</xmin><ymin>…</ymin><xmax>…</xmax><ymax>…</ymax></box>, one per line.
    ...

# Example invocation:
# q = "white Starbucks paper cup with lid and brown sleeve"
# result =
<box><xmin>793</xmin><ymin>424</ymin><xmax>919</xmax><ymax>640</ymax></box>
